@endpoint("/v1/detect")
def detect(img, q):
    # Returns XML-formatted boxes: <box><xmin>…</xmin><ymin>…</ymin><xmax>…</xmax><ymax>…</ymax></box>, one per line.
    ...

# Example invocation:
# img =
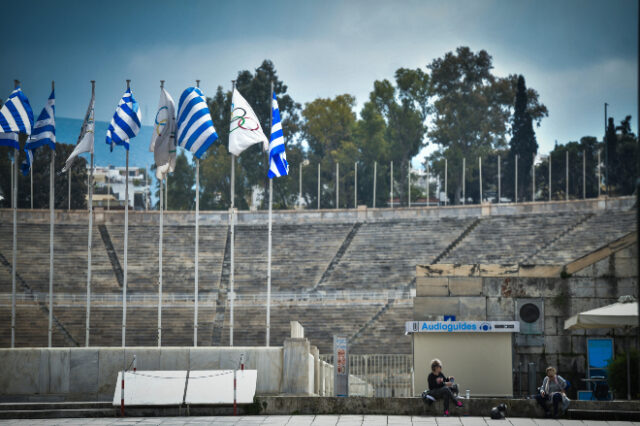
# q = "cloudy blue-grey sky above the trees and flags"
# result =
<box><xmin>0</xmin><ymin>0</ymin><xmax>638</xmax><ymax>160</ymax></box>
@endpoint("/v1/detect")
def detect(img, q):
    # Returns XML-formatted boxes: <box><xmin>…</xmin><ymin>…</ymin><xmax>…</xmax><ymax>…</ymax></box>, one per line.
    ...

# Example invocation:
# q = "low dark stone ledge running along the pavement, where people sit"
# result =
<box><xmin>0</xmin><ymin>396</ymin><xmax>640</xmax><ymax>420</ymax></box>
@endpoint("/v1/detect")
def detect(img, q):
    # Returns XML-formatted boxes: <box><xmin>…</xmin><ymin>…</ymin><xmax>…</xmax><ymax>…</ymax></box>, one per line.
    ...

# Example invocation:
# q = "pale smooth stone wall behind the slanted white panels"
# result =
<box><xmin>0</xmin><ymin>339</ymin><xmax>320</xmax><ymax>401</ymax></box>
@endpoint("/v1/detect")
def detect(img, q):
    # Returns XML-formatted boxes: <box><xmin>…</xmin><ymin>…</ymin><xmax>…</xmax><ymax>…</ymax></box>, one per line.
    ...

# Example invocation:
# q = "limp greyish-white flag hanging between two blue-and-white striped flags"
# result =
<box><xmin>149</xmin><ymin>88</ymin><xmax>176</xmax><ymax>180</ymax></box>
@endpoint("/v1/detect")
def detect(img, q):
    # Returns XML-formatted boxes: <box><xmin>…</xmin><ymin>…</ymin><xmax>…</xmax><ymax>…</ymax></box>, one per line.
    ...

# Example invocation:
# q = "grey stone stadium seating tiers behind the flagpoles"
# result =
<box><xmin>0</xmin><ymin>206</ymin><xmax>636</xmax><ymax>353</ymax></box>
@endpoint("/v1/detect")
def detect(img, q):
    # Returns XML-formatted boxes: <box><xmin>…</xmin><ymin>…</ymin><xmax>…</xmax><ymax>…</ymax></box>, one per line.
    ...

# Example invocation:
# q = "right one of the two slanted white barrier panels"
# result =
<box><xmin>185</xmin><ymin>370</ymin><xmax>258</xmax><ymax>404</ymax></box>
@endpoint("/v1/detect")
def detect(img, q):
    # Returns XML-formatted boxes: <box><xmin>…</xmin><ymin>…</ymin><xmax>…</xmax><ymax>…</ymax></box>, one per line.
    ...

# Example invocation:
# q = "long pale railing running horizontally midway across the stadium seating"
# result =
<box><xmin>0</xmin><ymin>290</ymin><xmax>415</xmax><ymax>307</ymax></box>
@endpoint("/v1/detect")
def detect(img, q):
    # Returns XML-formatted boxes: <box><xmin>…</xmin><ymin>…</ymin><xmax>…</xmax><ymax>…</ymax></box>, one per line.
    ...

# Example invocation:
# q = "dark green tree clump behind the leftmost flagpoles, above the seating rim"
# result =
<box><xmin>0</xmin><ymin>142</ymin><xmax>87</xmax><ymax>209</ymax></box>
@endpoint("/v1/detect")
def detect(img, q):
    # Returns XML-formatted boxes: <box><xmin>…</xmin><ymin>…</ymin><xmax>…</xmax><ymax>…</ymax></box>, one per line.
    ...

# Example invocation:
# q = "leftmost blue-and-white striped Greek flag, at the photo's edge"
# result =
<box><xmin>0</xmin><ymin>87</ymin><xmax>33</xmax><ymax>149</ymax></box>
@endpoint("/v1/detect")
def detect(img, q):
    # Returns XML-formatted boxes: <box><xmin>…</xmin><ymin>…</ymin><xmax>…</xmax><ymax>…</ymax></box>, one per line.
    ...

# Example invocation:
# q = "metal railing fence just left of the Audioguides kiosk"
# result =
<box><xmin>320</xmin><ymin>354</ymin><xmax>413</xmax><ymax>397</ymax></box>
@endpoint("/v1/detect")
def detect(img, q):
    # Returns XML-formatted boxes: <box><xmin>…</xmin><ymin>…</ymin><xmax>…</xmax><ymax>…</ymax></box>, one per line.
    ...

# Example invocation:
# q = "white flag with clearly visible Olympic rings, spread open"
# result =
<box><xmin>229</xmin><ymin>88</ymin><xmax>269</xmax><ymax>156</ymax></box>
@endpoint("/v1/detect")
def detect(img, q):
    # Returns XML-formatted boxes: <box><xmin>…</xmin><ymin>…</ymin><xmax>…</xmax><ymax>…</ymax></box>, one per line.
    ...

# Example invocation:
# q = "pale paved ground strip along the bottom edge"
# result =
<box><xmin>0</xmin><ymin>415</ymin><xmax>640</xmax><ymax>426</ymax></box>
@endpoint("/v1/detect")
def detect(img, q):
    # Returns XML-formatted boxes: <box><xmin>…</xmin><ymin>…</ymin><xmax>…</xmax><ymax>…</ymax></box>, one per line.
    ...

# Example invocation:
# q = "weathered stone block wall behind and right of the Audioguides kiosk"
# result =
<box><xmin>413</xmin><ymin>241</ymin><xmax>638</xmax><ymax>397</ymax></box>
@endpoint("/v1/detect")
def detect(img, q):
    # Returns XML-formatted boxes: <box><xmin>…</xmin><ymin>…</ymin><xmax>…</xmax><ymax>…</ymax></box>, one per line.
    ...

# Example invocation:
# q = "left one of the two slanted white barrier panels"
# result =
<box><xmin>113</xmin><ymin>370</ymin><xmax>187</xmax><ymax>406</ymax></box>
